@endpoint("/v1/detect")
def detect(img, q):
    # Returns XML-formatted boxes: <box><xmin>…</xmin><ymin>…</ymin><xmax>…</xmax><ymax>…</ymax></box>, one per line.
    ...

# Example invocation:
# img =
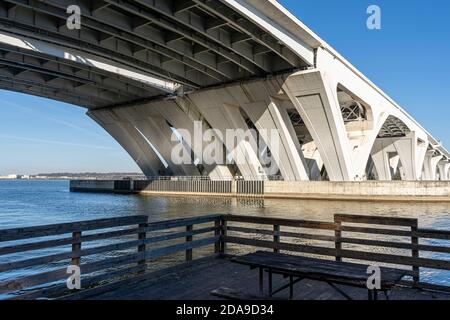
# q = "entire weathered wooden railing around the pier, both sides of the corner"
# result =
<box><xmin>0</xmin><ymin>215</ymin><xmax>450</xmax><ymax>299</ymax></box>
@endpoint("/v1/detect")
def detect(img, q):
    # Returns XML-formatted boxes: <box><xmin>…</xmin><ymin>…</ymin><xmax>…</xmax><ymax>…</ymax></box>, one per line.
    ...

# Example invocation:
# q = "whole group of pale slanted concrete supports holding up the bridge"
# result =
<box><xmin>86</xmin><ymin>65</ymin><xmax>438</xmax><ymax>181</ymax></box>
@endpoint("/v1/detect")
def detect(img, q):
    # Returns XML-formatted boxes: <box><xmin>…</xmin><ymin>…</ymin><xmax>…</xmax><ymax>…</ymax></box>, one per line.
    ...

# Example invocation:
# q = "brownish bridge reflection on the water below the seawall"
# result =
<box><xmin>135</xmin><ymin>195</ymin><xmax>450</xmax><ymax>229</ymax></box>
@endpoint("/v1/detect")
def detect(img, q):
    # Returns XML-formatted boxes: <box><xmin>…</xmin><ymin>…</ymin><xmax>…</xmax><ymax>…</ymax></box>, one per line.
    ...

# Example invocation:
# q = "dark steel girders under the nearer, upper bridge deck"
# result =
<box><xmin>0</xmin><ymin>0</ymin><xmax>312</xmax><ymax>106</ymax></box>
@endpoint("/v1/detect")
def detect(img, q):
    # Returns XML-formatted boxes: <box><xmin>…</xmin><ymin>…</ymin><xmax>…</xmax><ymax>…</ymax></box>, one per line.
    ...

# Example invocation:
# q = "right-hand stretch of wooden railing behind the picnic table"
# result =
<box><xmin>222</xmin><ymin>215</ymin><xmax>450</xmax><ymax>292</ymax></box>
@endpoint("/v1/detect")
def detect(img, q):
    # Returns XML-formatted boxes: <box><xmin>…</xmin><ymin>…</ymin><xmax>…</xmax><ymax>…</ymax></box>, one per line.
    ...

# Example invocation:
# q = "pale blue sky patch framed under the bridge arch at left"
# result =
<box><xmin>0</xmin><ymin>91</ymin><xmax>139</xmax><ymax>175</ymax></box>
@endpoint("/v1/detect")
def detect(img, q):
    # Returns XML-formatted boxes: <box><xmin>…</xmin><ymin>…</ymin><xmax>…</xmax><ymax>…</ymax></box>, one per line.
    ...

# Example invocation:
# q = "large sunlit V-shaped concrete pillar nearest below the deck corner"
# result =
<box><xmin>283</xmin><ymin>70</ymin><xmax>385</xmax><ymax>181</ymax></box>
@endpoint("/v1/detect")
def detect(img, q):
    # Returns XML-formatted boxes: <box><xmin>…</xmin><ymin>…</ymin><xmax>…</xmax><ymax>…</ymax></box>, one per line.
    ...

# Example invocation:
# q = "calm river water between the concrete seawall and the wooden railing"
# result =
<box><xmin>0</xmin><ymin>181</ymin><xmax>450</xmax><ymax>284</ymax></box>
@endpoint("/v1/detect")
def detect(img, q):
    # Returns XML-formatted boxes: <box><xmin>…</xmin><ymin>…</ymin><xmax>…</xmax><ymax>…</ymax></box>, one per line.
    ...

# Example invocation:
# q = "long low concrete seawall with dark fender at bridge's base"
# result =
<box><xmin>70</xmin><ymin>180</ymin><xmax>450</xmax><ymax>202</ymax></box>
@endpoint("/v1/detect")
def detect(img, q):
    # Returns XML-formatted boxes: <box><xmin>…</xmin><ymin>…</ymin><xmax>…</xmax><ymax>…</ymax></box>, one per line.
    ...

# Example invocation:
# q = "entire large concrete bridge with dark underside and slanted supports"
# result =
<box><xmin>0</xmin><ymin>0</ymin><xmax>450</xmax><ymax>181</ymax></box>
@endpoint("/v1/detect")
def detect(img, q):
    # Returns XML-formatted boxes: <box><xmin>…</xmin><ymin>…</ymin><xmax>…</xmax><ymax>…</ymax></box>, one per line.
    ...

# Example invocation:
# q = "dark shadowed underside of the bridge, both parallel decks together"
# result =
<box><xmin>0</xmin><ymin>0</ymin><xmax>312</xmax><ymax>108</ymax></box>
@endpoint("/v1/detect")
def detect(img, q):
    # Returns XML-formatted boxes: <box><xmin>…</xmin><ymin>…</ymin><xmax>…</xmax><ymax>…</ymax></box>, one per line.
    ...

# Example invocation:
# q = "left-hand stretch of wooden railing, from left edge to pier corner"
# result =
<box><xmin>0</xmin><ymin>215</ymin><xmax>220</xmax><ymax>299</ymax></box>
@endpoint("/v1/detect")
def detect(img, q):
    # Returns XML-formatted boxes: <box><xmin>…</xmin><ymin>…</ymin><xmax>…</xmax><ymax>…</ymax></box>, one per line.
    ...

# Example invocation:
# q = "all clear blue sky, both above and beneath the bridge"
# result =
<box><xmin>0</xmin><ymin>0</ymin><xmax>450</xmax><ymax>175</ymax></box>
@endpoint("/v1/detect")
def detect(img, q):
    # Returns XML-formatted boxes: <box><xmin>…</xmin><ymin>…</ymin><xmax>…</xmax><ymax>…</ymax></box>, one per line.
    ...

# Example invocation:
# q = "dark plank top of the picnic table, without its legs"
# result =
<box><xmin>231</xmin><ymin>251</ymin><xmax>408</xmax><ymax>289</ymax></box>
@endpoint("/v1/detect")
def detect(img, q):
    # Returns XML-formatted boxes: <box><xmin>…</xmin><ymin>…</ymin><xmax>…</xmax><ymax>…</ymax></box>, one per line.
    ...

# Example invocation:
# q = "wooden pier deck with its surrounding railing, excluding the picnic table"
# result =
<box><xmin>0</xmin><ymin>215</ymin><xmax>450</xmax><ymax>300</ymax></box>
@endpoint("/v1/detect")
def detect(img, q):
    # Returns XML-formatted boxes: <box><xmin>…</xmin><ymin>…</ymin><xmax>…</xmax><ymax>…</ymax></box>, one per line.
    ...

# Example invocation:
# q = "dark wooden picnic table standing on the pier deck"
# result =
<box><xmin>231</xmin><ymin>251</ymin><xmax>408</xmax><ymax>300</ymax></box>
